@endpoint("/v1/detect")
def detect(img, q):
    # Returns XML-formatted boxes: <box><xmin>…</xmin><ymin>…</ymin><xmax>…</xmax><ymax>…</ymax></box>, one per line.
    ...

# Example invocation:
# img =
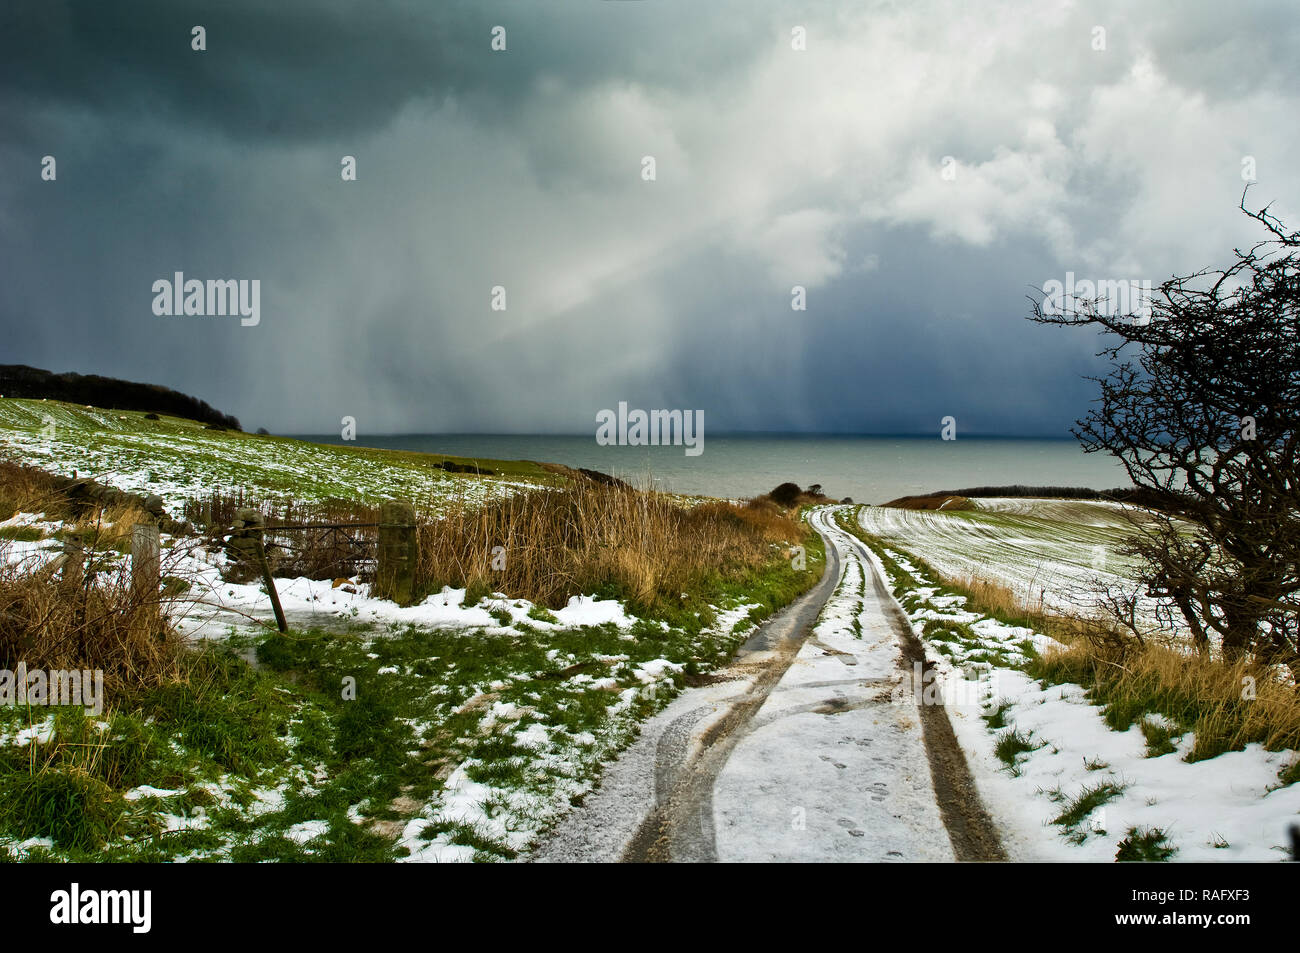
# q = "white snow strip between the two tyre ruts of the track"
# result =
<box><xmin>714</xmin><ymin>511</ymin><xmax>954</xmax><ymax>861</ymax></box>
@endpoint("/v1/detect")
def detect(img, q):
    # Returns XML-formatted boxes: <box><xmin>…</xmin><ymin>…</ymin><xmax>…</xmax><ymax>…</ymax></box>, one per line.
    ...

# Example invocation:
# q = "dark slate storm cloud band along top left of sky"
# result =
<box><xmin>0</xmin><ymin>0</ymin><xmax>763</xmax><ymax>142</ymax></box>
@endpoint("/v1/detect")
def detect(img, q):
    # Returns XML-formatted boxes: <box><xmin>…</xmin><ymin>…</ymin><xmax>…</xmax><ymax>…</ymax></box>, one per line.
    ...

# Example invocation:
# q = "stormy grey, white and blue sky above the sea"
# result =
<box><xmin>0</xmin><ymin>0</ymin><xmax>1300</xmax><ymax>436</ymax></box>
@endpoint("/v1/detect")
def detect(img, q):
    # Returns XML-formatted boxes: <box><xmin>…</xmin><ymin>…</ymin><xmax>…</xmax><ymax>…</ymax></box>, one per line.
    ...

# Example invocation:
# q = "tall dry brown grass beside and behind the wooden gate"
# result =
<box><xmin>192</xmin><ymin>476</ymin><xmax>803</xmax><ymax>598</ymax></box>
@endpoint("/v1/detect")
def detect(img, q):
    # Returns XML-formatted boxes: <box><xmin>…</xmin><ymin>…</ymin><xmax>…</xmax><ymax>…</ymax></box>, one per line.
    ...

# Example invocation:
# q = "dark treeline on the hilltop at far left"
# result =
<box><xmin>0</xmin><ymin>364</ymin><xmax>243</xmax><ymax>430</ymax></box>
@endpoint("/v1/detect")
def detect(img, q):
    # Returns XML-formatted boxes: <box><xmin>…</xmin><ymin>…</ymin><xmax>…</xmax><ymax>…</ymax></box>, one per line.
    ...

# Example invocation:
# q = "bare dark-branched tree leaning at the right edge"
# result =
<box><xmin>1030</xmin><ymin>194</ymin><xmax>1300</xmax><ymax>676</ymax></box>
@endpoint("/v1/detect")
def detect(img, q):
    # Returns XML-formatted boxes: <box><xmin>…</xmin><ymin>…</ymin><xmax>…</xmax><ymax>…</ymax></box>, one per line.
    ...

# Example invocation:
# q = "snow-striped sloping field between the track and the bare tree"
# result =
<box><xmin>858</xmin><ymin>498</ymin><xmax>1141</xmax><ymax>610</ymax></box>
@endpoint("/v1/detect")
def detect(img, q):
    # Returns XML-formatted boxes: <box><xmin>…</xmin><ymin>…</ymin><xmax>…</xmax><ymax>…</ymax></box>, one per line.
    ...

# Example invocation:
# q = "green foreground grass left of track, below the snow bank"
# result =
<box><xmin>0</xmin><ymin>527</ymin><xmax>824</xmax><ymax>862</ymax></box>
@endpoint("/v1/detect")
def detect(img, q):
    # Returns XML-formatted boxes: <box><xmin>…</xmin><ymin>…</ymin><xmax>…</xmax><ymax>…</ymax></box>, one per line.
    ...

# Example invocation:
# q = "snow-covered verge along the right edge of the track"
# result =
<box><xmin>842</xmin><ymin>512</ymin><xmax>1300</xmax><ymax>862</ymax></box>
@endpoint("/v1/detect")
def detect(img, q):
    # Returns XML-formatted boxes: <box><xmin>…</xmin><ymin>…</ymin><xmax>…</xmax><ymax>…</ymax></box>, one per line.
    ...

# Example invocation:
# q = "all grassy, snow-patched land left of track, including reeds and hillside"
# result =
<box><xmin>0</xmin><ymin>400</ymin><xmax>824</xmax><ymax>861</ymax></box>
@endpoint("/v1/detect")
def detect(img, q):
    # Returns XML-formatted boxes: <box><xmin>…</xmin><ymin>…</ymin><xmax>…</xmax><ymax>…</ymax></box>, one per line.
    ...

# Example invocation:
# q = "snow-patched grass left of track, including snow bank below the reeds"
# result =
<box><xmin>0</xmin><ymin>504</ymin><xmax>774</xmax><ymax>863</ymax></box>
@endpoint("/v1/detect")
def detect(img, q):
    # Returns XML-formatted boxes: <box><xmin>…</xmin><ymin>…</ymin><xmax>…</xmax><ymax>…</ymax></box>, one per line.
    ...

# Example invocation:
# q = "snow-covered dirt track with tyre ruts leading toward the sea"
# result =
<box><xmin>533</xmin><ymin>510</ymin><xmax>1002</xmax><ymax>862</ymax></box>
